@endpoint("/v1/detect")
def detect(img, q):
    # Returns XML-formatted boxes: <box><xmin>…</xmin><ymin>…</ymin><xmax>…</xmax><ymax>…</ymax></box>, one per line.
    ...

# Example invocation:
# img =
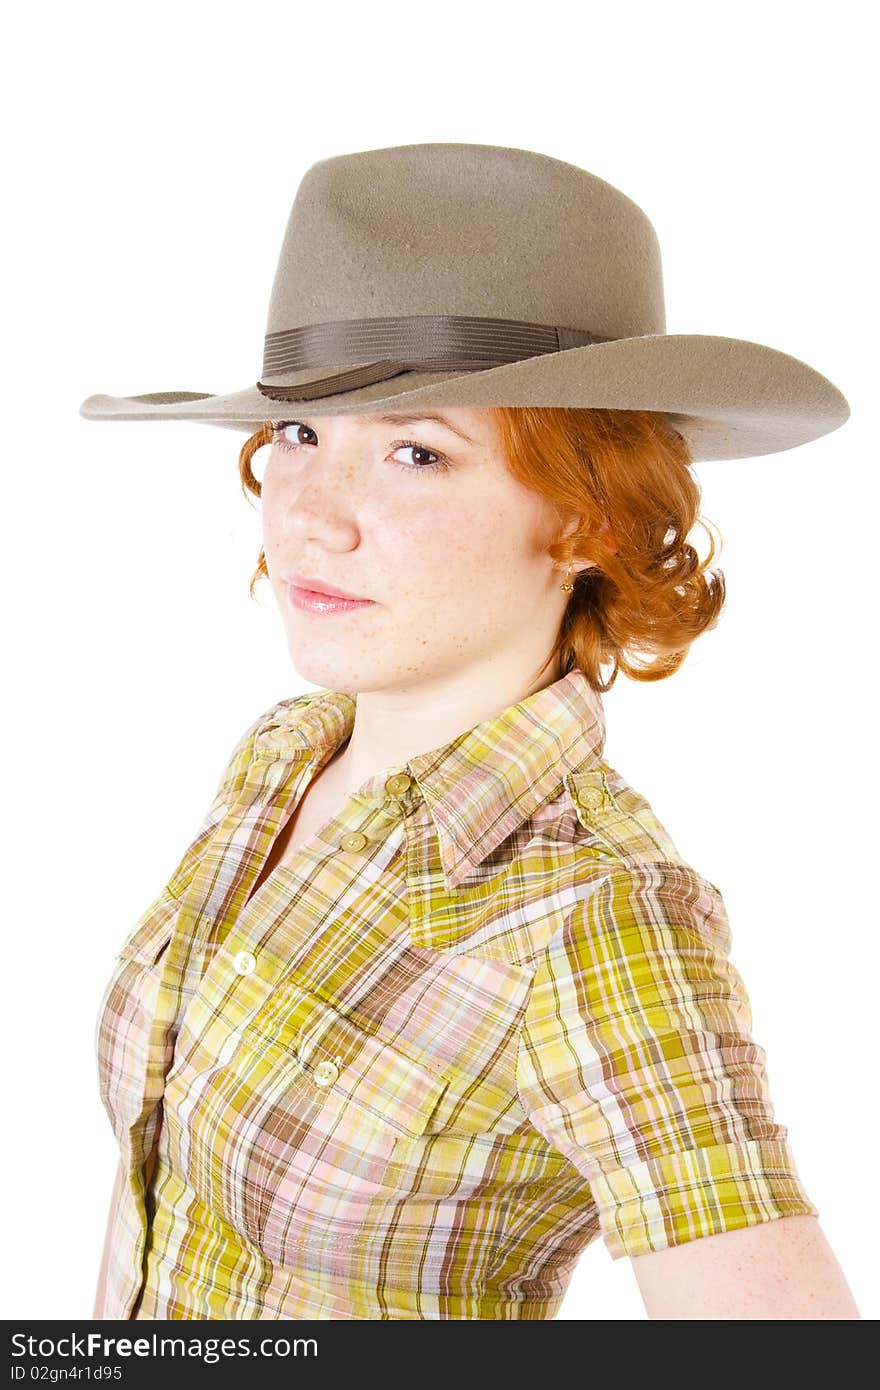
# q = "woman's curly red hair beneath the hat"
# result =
<box><xmin>239</xmin><ymin>406</ymin><xmax>726</xmax><ymax>691</ymax></box>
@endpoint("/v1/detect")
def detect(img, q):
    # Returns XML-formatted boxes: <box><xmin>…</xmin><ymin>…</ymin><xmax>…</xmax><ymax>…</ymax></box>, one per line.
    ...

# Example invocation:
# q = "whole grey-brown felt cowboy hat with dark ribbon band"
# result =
<box><xmin>79</xmin><ymin>145</ymin><xmax>849</xmax><ymax>461</ymax></box>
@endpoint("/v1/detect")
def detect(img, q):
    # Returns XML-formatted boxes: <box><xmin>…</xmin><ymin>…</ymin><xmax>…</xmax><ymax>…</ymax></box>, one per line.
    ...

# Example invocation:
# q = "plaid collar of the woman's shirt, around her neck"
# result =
<box><xmin>257</xmin><ymin>667</ymin><xmax>605</xmax><ymax>888</ymax></box>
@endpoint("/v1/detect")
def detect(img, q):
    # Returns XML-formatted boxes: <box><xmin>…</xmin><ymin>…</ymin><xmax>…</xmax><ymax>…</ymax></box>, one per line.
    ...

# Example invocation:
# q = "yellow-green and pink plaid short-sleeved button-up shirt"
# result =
<box><xmin>96</xmin><ymin>670</ymin><xmax>819</xmax><ymax>1319</ymax></box>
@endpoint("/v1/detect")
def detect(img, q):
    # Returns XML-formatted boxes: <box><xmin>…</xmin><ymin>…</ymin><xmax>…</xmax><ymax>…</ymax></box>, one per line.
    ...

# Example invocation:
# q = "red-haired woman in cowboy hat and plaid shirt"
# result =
<box><xmin>81</xmin><ymin>145</ymin><xmax>858</xmax><ymax>1319</ymax></box>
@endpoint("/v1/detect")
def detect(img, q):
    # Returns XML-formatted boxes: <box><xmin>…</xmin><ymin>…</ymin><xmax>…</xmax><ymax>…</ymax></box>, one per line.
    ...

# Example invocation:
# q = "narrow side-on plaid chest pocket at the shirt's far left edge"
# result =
<box><xmin>95</xmin><ymin>891</ymin><xmax>181</xmax><ymax>1143</ymax></box>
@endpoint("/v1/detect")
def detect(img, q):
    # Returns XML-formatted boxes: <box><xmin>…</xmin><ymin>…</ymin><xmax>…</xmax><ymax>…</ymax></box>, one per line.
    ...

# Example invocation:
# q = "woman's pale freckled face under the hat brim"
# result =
<box><xmin>261</xmin><ymin>403</ymin><xmax>566</xmax><ymax>691</ymax></box>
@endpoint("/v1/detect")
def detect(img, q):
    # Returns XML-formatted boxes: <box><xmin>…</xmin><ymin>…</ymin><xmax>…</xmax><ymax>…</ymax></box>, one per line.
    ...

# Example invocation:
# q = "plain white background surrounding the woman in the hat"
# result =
<box><xmin>0</xmin><ymin>0</ymin><xmax>880</xmax><ymax>1319</ymax></box>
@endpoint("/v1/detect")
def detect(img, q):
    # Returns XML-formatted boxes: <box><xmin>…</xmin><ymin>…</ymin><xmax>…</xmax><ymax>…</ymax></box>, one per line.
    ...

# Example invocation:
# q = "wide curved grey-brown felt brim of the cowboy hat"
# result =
<box><xmin>79</xmin><ymin>334</ymin><xmax>849</xmax><ymax>463</ymax></box>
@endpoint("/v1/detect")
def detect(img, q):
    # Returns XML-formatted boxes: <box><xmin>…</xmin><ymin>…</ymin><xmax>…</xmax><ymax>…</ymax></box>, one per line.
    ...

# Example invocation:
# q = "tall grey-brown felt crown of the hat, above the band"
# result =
<box><xmin>266</xmin><ymin>143</ymin><xmax>666</xmax><ymax>347</ymax></box>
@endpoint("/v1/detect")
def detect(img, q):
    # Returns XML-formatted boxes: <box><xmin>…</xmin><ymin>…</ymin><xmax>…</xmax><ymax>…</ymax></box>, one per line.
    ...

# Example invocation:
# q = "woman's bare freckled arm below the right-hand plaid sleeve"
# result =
<box><xmin>630</xmin><ymin>1216</ymin><xmax>862</xmax><ymax>1321</ymax></box>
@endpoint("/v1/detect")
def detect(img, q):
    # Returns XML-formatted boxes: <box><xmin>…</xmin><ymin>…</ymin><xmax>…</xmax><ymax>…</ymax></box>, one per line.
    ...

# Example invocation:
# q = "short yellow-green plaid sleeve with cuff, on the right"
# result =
<box><xmin>517</xmin><ymin>860</ymin><xmax>819</xmax><ymax>1259</ymax></box>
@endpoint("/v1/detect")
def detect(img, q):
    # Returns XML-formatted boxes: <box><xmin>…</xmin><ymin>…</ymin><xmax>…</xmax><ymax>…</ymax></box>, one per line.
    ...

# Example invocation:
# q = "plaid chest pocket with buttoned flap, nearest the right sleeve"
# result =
<box><xmin>164</xmin><ymin>981</ymin><xmax>448</xmax><ymax>1264</ymax></box>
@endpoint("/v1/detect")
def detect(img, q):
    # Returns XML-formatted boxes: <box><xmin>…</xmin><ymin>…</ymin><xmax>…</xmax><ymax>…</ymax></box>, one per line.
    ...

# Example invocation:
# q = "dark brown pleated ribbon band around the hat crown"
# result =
<box><xmin>257</xmin><ymin>314</ymin><xmax>616</xmax><ymax>400</ymax></box>
